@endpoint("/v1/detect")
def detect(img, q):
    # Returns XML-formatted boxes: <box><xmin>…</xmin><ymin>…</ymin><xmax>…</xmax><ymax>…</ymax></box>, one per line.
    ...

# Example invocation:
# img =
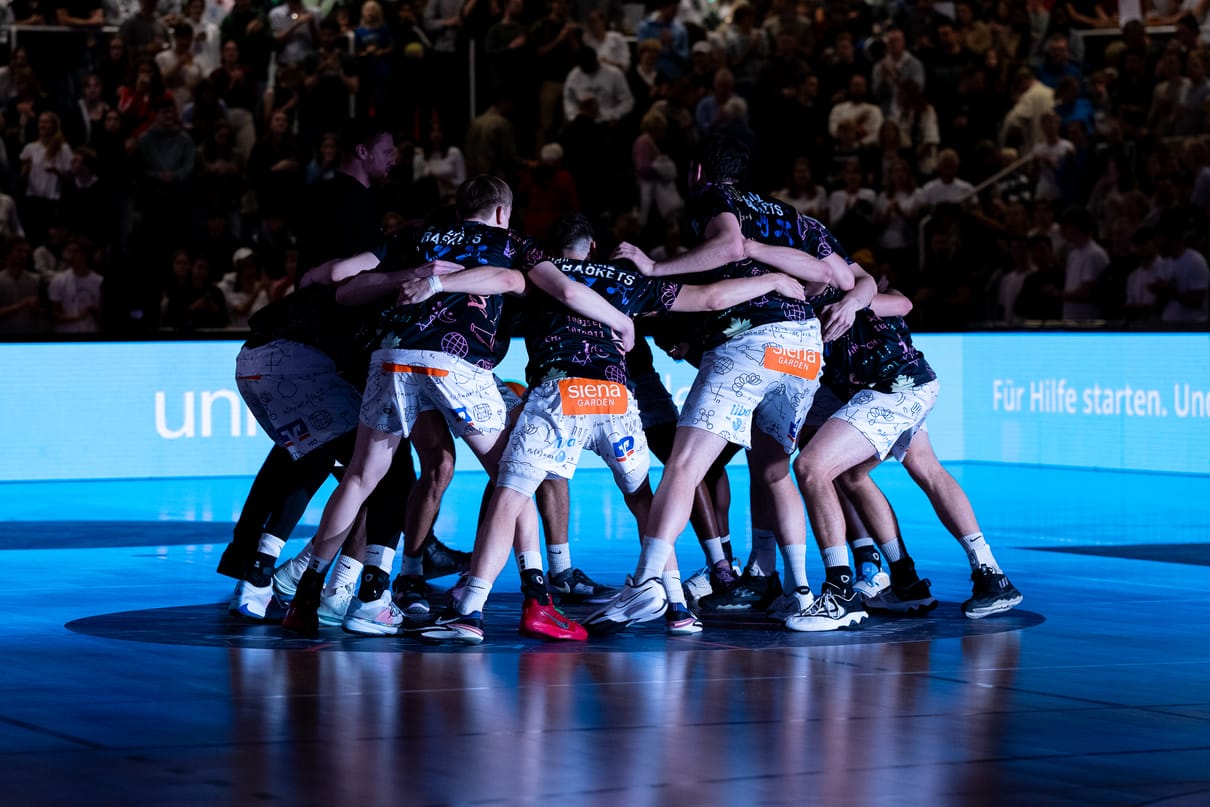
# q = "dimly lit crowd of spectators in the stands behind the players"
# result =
<box><xmin>0</xmin><ymin>0</ymin><xmax>1210</xmax><ymax>336</ymax></box>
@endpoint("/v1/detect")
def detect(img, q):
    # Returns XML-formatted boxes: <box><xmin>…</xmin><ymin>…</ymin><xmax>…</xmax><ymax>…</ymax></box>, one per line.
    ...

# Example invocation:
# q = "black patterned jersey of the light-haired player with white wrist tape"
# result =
<box><xmin>381</xmin><ymin>221</ymin><xmax>534</xmax><ymax>370</ymax></box>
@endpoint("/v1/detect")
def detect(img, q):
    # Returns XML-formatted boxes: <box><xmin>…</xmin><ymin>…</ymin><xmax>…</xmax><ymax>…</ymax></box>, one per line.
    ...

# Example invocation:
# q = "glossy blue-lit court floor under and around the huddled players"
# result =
<box><xmin>0</xmin><ymin>466</ymin><xmax>1210</xmax><ymax>807</ymax></box>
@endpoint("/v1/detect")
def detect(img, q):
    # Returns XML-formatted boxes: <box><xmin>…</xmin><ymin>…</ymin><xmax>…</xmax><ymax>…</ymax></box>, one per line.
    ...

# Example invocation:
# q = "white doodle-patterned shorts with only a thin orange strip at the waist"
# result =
<box><xmin>361</xmin><ymin>348</ymin><xmax>507</xmax><ymax>437</ymax></box>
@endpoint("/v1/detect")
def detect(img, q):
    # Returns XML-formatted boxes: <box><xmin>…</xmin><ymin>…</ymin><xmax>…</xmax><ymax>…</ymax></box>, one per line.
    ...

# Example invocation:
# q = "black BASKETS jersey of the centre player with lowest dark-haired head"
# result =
<box><xmin>525</xmin><ymin>258</ymin><xmax>681</xmax><ymax>387</ymax></box>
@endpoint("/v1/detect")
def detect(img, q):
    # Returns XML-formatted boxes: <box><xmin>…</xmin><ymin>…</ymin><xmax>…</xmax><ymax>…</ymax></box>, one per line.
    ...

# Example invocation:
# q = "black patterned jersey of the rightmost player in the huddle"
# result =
<box><xmin>812</xmin><ymin>288</ymin><xmax>937</xmax><ymax>400</ymax></box>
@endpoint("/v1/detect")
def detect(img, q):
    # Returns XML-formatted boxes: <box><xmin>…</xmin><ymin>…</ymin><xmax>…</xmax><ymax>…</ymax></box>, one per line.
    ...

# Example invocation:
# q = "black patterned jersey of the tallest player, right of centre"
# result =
<box><xmin>688</xmin><ymin>184</ymin><xmax>843</xmax><ymax>348</ymax></box>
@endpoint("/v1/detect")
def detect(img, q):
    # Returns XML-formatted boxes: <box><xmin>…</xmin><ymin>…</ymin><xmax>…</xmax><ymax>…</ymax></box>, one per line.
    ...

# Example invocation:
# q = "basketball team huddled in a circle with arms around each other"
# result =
<box><xmin>219</xmin><ymin>123</ymin><xmax>1021</xmax><ymax>645</ymax></box>
